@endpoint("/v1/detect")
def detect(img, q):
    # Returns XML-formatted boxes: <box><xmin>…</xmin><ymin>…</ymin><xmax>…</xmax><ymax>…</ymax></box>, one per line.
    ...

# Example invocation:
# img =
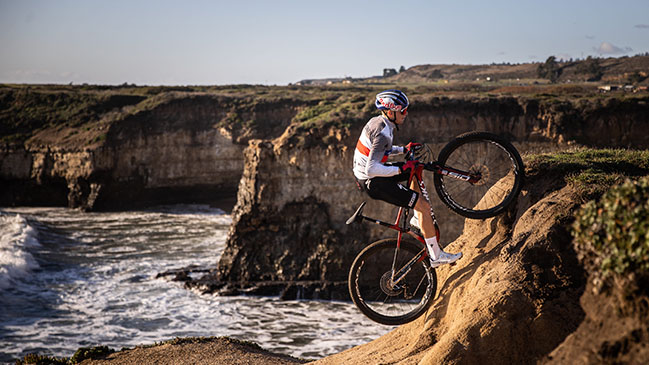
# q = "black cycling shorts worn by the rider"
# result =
<box><xmin>359</xmin><ymin>174</ymin><xmax>419</xmax><ymax>209</ymax></box>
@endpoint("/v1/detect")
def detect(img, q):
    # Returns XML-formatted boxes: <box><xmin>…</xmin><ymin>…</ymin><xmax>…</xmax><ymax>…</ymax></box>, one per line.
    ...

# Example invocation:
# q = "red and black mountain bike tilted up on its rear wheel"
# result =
<box><xmin>347</xmin><ymin>132</ymin><xmax>524</xmax><ymax>325</ymax></box>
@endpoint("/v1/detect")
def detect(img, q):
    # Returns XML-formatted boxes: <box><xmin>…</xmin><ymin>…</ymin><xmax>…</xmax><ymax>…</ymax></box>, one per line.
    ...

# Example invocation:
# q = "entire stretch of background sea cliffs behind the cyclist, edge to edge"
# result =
<box><xmin>0</xmin><ymin>88</ymin><xmax>649</xmax><ymax>290</ymax></box>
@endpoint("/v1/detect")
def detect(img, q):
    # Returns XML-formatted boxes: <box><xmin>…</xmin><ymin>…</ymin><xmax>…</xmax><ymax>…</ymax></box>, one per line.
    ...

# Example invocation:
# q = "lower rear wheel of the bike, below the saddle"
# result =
<box><xmin>348</xmin><ymin>239</ymin><xmax>437</xmax><ymax>325</ymax></box>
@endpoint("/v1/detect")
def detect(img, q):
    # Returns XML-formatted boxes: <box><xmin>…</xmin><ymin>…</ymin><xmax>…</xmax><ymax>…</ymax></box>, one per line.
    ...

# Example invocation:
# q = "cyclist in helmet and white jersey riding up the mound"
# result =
<box><xmin>354</xmin><ymin>89</ymin><xmax>462</xmax><ymax>267</ymax></box>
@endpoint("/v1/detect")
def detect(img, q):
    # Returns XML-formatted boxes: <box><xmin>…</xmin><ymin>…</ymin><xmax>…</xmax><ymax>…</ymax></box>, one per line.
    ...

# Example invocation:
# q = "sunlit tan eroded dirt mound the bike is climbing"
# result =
<box><xmin>317</xmin><ymin>181</ymin><xmax>586</xmax><ymax>364</ymax></box>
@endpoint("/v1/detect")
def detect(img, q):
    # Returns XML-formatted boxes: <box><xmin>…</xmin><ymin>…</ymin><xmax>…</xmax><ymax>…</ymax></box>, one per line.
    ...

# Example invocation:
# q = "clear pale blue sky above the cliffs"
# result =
<box><xmin>0</xmin><ymin>0</ymin><xmax>649</xmax><ymax>85</ymax></box>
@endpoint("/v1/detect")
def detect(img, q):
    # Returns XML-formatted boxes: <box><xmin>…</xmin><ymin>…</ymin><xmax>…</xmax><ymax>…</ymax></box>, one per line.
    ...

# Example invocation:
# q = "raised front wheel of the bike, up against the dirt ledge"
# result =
<box><xmin>434</xmin><ymin>132</ymin><xmax>525</xmax><ymax>219</ymax></box>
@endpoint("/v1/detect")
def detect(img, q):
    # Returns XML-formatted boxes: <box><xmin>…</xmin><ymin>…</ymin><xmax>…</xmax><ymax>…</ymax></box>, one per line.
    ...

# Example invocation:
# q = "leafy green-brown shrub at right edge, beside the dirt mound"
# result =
<box><xmin>573</xmin><ymin>176</ymin><xmax>649</xmax><ymax>276</ymax></box>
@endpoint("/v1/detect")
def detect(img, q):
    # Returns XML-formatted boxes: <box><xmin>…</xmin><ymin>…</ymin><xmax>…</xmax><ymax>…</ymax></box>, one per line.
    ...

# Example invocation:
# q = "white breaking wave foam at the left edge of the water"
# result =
<box><xmin>0</xmin><ymin>212</ymin><xmax>40</xmax><ymax>290</ymax></box>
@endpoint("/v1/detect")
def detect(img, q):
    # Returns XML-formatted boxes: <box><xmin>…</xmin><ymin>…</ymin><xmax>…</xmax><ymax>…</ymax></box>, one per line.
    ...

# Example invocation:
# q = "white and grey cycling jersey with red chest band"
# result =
<box><xmin>354</xmin><ymin>115</ymin><xmax>404</xmax><ymax>180</ymax></box>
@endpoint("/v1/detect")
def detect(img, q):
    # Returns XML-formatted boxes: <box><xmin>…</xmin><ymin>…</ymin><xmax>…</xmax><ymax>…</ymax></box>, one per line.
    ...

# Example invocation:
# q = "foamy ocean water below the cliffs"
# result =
<box><xmin>0</xmin><ymin>205</ymin><xmax>393</xmax><ymax>363</ymax></box>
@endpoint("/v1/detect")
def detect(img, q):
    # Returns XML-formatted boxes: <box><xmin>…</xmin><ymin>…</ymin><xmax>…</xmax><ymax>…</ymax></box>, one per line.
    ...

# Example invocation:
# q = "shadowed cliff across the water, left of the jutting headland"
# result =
<box><xmin>0</xmin><ymin>93</ymin><xmax>304</xmax><ymax>210</ymax></box>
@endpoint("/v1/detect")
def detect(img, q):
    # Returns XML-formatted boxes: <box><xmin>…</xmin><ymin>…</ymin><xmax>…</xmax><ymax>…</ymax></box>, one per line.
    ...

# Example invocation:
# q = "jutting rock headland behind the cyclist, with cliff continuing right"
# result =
<box><xmin>196</xmin><ymin>92</ymin><xmax>649</xmax><ymax>297</ymax></box>
